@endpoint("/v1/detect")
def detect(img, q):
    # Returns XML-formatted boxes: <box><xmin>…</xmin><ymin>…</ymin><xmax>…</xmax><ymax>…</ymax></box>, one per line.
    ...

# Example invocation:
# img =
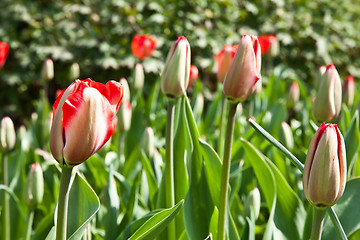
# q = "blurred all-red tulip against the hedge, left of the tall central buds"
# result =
<box><xmin>131</xmin><ymin>35</ymin><xmax>156</xmax><ymax>60</ymax></box>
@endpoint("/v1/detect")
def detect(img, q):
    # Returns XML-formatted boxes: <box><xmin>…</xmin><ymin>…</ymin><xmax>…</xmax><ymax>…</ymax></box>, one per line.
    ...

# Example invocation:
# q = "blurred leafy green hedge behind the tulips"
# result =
<box><xmin>0</xmin><ymin>0</ymin><xmax>360</xmax><ymax>124</ymax></box>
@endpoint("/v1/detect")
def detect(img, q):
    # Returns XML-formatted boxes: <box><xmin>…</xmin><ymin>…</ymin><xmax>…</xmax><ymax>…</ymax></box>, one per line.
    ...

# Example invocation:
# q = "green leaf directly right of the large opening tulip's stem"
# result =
<box><xmin>67</xmin><ymin>172</ymin><xmax>100</xmax><ymax>240</ymax></box>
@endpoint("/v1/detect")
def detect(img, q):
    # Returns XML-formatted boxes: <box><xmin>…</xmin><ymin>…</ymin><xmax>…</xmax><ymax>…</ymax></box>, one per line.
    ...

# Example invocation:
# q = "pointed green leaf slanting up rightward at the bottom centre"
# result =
<box><xmin>129</xmin><ymin>200</ymin><xmax>184</xmax><ymax>240</ymax></box>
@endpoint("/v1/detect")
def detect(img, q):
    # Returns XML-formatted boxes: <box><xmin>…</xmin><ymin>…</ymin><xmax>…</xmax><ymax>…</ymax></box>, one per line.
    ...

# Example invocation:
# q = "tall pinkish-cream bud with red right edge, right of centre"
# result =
<box><xmin>223</xmin><ymin>35</ymin><xmax>261</xmax><ymax>102</ymax></box>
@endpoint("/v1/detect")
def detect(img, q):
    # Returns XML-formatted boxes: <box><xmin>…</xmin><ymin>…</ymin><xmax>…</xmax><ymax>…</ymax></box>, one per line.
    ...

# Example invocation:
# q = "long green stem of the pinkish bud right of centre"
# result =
<box><xmin>218</xmin><ymin>103</ymin><xmax>237</xmax><ymax>240</ymax></box>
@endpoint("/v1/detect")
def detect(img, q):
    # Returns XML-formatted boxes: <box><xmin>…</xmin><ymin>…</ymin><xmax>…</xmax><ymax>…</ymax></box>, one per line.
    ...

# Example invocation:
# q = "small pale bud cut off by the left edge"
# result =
<box><xmin>0</xmin><ymin>116</ymin><xmax>16</xmax><ymax>151</ymax></box>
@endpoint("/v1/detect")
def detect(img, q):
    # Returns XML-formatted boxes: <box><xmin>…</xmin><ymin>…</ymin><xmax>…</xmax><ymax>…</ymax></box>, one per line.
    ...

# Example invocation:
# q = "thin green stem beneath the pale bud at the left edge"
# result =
<box><xmin>2</xmin><ymin>153</ymin><xmax>10</xmax><ymax>240</ymax></box>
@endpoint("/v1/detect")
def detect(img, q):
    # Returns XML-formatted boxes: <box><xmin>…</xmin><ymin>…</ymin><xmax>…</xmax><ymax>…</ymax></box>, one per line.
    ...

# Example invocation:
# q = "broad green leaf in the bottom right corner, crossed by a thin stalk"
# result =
<box><xmin>323</xmin><ymin>178</ymin><xmax>360</xmax><ymax>240</ymax></box>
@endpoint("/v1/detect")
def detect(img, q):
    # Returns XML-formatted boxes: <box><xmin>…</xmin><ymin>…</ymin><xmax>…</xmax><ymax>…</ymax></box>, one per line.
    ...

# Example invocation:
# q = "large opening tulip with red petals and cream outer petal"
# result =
<box><xmin>50</xmin><ymin>78</ymin><xmax>123</xmax><ymax>166</ymax></box>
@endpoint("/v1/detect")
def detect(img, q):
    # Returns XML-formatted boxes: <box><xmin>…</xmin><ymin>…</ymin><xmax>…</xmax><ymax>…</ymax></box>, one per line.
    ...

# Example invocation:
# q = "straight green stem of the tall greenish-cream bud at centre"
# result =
<box><xmin>165</xmin><ymin>99</ymin><xmax>176</xmax><ymax>240</ymax></box>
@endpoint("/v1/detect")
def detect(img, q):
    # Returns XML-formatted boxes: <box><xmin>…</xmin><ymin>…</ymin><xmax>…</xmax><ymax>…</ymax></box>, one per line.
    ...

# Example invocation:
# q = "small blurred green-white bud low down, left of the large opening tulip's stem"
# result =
<box><xmin>23</xmin><ymin>163</ymin><xmax>44</xmax><ymax>208</ymax></box>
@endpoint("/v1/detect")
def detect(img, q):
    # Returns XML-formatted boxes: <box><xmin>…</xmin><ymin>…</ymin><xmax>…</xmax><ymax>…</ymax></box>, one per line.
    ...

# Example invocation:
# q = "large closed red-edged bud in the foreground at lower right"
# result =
<box><xmin>303</xmin><ymin>123</ymin><xmax>346</xmax><ymax>208</ymax></box>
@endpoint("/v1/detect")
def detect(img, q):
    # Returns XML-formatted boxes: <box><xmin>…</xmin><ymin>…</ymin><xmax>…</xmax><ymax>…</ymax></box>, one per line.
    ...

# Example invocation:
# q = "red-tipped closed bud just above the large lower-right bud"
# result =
<box><xmin>313</xmin><ymin>64</ymin><xmax>342</xmax><ymax>121</ymax></box>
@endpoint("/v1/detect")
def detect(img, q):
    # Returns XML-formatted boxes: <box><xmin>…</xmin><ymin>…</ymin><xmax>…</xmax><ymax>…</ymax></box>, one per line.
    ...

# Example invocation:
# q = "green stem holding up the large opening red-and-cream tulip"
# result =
<box><xmin>56</xmin><ymin>166</ymin><xmax>73</xmax><ymax>240</ymax></box>
